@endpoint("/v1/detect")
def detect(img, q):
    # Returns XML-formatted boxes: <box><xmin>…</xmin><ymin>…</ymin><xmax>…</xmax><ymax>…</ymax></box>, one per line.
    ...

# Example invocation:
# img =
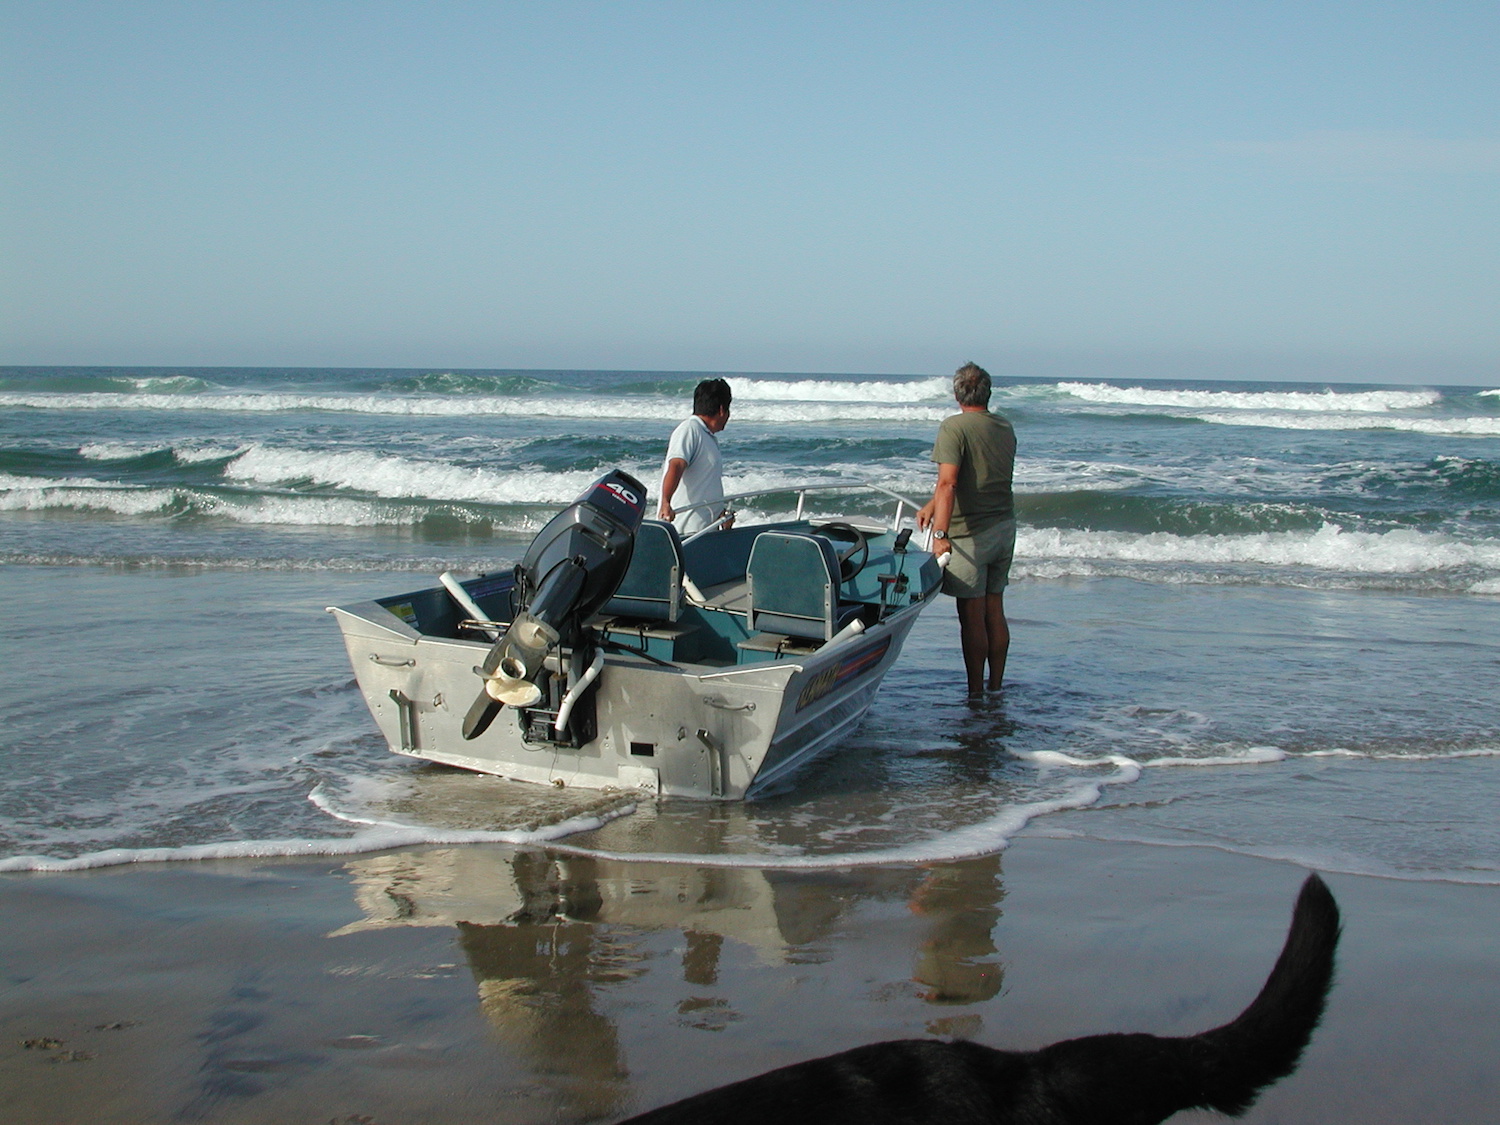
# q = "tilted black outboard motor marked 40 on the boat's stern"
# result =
<box><xmin>464</xmin><ymin>470</ymin><xmax>647</xmax><ymax>738</ymax></box>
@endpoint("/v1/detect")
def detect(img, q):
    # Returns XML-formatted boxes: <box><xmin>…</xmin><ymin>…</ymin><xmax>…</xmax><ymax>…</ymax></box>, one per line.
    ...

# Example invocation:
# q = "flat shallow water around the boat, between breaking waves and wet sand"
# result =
<box><xmin>0</xmin><ymin>567</ymin><xmax>1500</xmax><ymax>882</ymax></box>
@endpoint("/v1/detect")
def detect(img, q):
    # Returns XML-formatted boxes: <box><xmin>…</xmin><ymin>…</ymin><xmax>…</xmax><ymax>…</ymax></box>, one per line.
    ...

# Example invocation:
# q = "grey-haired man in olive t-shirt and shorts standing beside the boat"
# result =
<box><xmin>917</xmin><ymin>363</ymin><xmax>1016</xmax><ymax>696</ymax></box>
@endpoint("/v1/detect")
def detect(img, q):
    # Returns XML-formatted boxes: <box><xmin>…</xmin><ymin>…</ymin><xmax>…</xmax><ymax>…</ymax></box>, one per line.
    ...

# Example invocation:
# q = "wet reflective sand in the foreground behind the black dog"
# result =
<box><xmin>0</xmin><ymin>837</ymin><xmax>1500</xmax><ymax>1125</ymax></box>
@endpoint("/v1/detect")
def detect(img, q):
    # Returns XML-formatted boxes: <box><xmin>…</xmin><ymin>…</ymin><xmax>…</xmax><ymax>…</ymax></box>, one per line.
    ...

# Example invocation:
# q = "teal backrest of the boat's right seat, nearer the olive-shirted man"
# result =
<box><xmin>746</xmin><ymin>531</ymin><xmax>839</xmax><ymax>641</ymax></box>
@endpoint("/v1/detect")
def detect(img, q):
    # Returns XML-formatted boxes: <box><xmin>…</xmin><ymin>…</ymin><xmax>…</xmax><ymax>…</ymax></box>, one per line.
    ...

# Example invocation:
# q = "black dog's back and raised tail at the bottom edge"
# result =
<box><xmin>621</xmin><ymin>875</ymin><xmax>1340</xmax><ymax>1125</ymax></box>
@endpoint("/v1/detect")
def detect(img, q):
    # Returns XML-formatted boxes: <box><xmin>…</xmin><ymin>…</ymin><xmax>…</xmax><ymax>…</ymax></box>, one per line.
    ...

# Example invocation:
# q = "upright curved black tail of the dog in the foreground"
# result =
<box><xmin>1185</xmin><ymin>875</ymin><xmax>1340</xmax><ymax>1116</ymax></box>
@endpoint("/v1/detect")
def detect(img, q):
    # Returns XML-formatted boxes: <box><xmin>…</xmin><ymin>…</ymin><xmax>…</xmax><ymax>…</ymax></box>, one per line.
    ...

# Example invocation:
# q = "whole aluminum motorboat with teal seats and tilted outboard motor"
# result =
<box><xmin>329</xmin><ymin>471</ymin><xmax>942</xmax><ymax>801</ymax></box>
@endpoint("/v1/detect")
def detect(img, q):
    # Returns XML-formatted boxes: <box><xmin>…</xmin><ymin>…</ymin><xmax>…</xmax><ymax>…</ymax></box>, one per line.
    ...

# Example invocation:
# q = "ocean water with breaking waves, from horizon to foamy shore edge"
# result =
<box><xmin>0</xmin><ymin>368</ymin><xmax>1500</xmax><ymax>884</ymax></box>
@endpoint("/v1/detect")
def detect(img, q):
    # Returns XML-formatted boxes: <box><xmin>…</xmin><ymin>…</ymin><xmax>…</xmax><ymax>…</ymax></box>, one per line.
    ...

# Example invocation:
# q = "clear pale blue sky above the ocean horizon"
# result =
<box><xmin>0</xmin><ymin>0</ymin><xmax>1500</xmax><ymax>383</ymax></box>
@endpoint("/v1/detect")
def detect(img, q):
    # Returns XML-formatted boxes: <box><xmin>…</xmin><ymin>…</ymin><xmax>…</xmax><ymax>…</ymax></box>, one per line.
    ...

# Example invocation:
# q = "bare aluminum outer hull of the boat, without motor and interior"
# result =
<box><xmin>332</xmin><ymin>602</ymin><xmax>924</xmax><ymax>801</ymax></box>
